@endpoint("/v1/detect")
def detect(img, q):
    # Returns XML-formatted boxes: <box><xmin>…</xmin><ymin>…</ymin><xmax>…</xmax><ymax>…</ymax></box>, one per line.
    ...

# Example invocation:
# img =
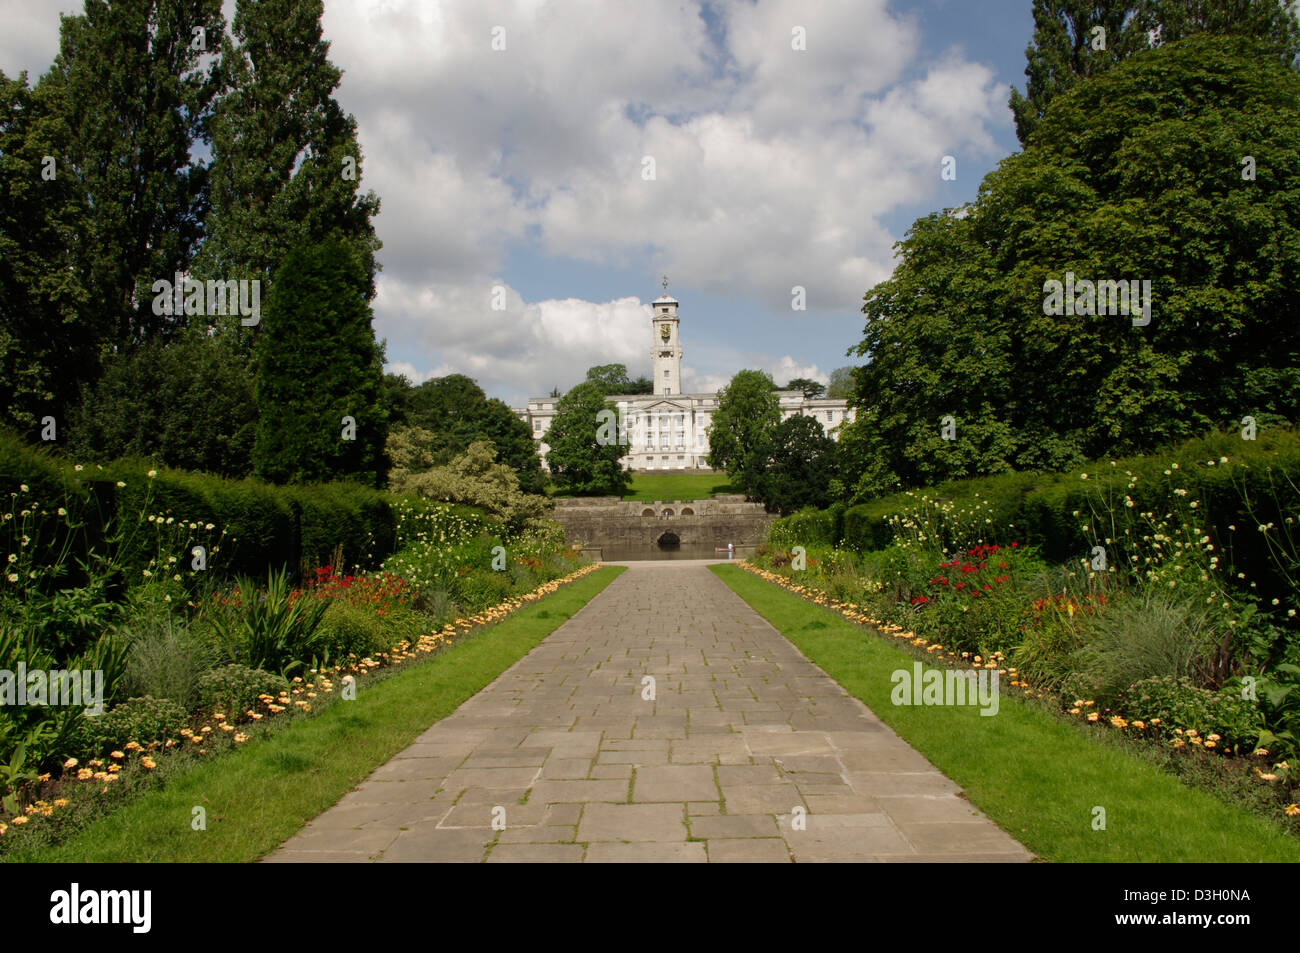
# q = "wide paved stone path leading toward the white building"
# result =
<box><xmin>268</xmin><ymin>562</ymin><xmax>1030</xmax><ymax>862</ymax></box>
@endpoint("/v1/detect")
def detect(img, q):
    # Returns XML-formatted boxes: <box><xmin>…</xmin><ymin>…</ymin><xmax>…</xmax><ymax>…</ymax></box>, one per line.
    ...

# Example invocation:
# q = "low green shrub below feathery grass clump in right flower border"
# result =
<box><xmin>1117</xmin><ymin>675</ymin><xmax>1264</xmax><ymax>750</ymax></box>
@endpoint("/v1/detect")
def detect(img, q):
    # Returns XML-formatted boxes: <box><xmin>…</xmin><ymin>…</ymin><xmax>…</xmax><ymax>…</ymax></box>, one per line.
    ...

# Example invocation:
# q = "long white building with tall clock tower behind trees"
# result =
<box><xmin>515</xmin><ymin>294</ymin><xmax>854</xmax><ymax>469</ymax></box>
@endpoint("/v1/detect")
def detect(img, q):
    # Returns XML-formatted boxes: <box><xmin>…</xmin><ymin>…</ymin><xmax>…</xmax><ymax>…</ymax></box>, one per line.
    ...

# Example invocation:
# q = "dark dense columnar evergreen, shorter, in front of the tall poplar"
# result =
<box><xmin>252</xmin><ymin>239</ymin><xmax>387</xmax><ymax>486</ymax></box>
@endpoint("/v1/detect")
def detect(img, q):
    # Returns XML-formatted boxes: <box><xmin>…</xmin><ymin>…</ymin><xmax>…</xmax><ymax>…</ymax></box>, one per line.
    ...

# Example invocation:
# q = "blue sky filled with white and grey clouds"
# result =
<box><xmin>0</xmin><ymin>0</ymin><xmax>1032</xmax><ymax>406</ymax></box>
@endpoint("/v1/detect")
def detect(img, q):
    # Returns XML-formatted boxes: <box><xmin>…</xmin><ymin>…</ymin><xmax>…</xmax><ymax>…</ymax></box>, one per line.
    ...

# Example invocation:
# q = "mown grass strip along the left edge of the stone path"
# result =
<box><xmin>5</xmin><ymin>567</ymin><xmax>624</xmax><ymax>863</ymax></box>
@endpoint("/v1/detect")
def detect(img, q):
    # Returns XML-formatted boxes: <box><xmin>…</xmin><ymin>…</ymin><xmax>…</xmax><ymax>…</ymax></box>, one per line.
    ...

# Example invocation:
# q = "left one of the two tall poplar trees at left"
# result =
<box><xmin>38</xmin><ymin>0</ymin><xmax>225</xmax><ymax>348</ymax></box>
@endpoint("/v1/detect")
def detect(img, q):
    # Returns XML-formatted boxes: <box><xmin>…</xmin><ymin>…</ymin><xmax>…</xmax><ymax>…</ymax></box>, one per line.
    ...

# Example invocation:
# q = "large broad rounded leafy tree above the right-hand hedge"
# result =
<box><xmin>841</xmin><ymin>35</ymin><xmax>1300</xmax><ymax>501</ymax></box>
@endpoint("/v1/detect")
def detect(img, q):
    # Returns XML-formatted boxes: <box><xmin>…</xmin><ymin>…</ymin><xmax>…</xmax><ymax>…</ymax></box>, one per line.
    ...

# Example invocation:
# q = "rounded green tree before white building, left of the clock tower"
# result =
<box><xmin>546</xmin><ymin>381</ymin><xmax>631</xmax><ymax>495</ymax></box>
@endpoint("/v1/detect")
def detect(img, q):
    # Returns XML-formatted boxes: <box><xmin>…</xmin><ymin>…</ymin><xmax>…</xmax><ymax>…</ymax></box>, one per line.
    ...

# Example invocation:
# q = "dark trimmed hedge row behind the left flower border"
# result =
<box><xmin>0</xmin><ymin>432</ymin><xmax>485</xmax><ymax>579</ymax></box>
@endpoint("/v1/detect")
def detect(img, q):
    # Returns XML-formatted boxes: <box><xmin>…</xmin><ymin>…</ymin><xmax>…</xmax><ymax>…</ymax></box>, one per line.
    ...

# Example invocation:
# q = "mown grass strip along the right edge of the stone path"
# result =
<box><xmin>710</xmin><ymin>564</ymin><xmax>1300</xmax><ymax>863</ymax></box>
